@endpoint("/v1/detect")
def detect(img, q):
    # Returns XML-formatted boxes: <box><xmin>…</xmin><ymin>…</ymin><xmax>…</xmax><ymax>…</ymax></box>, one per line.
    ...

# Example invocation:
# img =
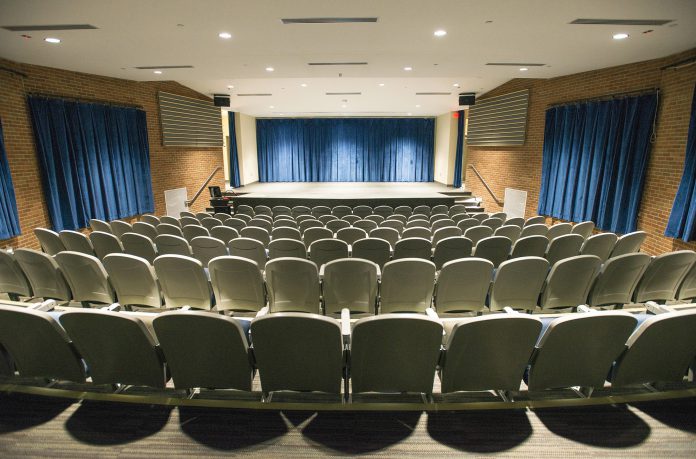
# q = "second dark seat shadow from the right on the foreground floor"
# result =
<box><xmin>534</xmin><ymin>405</ymin><xmax>650</xmax><ymax>448</ymax></box>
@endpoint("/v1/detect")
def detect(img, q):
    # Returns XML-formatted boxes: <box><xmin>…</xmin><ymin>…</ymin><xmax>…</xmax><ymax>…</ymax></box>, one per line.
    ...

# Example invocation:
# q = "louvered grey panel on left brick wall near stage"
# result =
<box><xmin>158</xmin><ymin>92</ymin><xmax>222</xmax><ymax>147</ymax></box>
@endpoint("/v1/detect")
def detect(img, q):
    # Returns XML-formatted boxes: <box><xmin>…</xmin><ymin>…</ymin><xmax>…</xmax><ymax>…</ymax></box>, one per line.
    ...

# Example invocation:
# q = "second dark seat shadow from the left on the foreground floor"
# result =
<box><xmin>65</xmin><ymin>400</ymin><xmax>172</xmax><ymax>445</ymax></box>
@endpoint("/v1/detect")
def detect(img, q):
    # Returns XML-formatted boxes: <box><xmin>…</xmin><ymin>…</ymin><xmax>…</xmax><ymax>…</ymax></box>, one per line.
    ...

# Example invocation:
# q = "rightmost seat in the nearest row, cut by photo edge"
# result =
<box><xmin>610</xmin><ymin>311</ymin><xmax>696</xmax><ymax>388</ymax></box>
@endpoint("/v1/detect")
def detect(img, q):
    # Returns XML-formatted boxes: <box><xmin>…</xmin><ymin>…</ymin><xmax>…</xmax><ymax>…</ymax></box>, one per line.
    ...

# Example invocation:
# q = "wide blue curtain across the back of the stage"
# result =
<box><xmin>256</xmin><ymin>118</ymin><xmax>435</xmax><ymax>182</ymax></box>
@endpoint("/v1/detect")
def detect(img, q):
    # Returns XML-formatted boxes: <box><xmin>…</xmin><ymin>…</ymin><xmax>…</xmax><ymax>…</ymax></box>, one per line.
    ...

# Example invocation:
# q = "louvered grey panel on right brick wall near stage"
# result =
<box><xmin>467</xmin><ymin>89</ymin><xmax>529</xmax><ymax>146</ymax></box>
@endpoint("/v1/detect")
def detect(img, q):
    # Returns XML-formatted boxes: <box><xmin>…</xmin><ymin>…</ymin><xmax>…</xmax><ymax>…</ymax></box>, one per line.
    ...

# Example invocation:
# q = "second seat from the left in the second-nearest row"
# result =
<box><xmin>13</xmin><ymin>249</ymin><xmax>72</xmax><ymax>304</ymax></box>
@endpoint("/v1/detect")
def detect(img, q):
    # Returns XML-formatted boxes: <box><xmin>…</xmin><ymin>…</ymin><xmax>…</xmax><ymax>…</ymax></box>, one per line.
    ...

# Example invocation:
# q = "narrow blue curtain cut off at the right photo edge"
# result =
<box><xmin>665</xmin><ymin>87</ymin><xmax>696</xmax><ymax>241</ymax></box>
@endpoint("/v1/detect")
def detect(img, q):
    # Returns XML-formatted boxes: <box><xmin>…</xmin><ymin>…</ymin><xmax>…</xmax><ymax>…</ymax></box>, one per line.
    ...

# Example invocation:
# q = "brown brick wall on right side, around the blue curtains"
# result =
<box><xmin>466</xmin><ymin>49</ymin><xmax>696</xmax><ymax>254</ymax></box>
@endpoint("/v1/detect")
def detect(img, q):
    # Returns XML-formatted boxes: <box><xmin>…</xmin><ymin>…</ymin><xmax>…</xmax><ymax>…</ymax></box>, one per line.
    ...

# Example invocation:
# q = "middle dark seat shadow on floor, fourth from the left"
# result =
<box><xmin>302</xmin><ymin>411</ymin><xmax>422</xmax><ymax>454</ymax></box>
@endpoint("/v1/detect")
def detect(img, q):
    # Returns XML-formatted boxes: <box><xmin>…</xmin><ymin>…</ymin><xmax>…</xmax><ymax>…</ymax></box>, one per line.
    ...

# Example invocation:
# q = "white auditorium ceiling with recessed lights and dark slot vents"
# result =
<box><xmin>0</xmin><ymin>0</ymin><xmax>696</xmax><ymax>116</ymax></box>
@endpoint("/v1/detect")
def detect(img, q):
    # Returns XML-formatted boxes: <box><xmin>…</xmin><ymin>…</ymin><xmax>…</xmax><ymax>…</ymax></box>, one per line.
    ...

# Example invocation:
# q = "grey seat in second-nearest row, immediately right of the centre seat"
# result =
<box><xmin>379</xmin><ymin>258</ymin><xmax>435</xmax><ymax>314</ymax></box>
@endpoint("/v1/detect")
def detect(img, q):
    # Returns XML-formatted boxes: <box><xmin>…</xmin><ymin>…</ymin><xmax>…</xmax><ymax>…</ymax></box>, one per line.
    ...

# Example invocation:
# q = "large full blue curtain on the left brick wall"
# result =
<box><xmin>29</xmin><ymin>96</ymin><xmax>154</xmax><ymax>231</ymax></box>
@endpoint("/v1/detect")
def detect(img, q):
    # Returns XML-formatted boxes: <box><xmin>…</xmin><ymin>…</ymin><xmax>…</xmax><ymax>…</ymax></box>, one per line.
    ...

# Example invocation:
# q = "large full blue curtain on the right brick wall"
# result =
<box><xmin>538</xmin><ymin>93</ymin><xmax>657</xmax><ymax>233</ymax></box>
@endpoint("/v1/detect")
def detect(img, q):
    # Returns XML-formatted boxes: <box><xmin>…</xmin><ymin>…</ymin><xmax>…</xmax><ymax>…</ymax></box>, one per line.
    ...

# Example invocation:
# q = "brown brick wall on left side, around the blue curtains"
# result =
<box><xmin>0</xmin><ymin>59</ymin><xmax>225</xmax><ymax>252</ymax></box>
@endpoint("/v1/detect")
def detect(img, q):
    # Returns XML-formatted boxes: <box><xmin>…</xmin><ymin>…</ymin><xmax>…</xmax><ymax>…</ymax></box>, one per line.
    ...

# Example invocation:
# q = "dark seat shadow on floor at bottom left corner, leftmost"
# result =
<box><xmin>0</xmin><ymin>393</ymin><xmax>75</xmax><ymax>433</ymax></box>
